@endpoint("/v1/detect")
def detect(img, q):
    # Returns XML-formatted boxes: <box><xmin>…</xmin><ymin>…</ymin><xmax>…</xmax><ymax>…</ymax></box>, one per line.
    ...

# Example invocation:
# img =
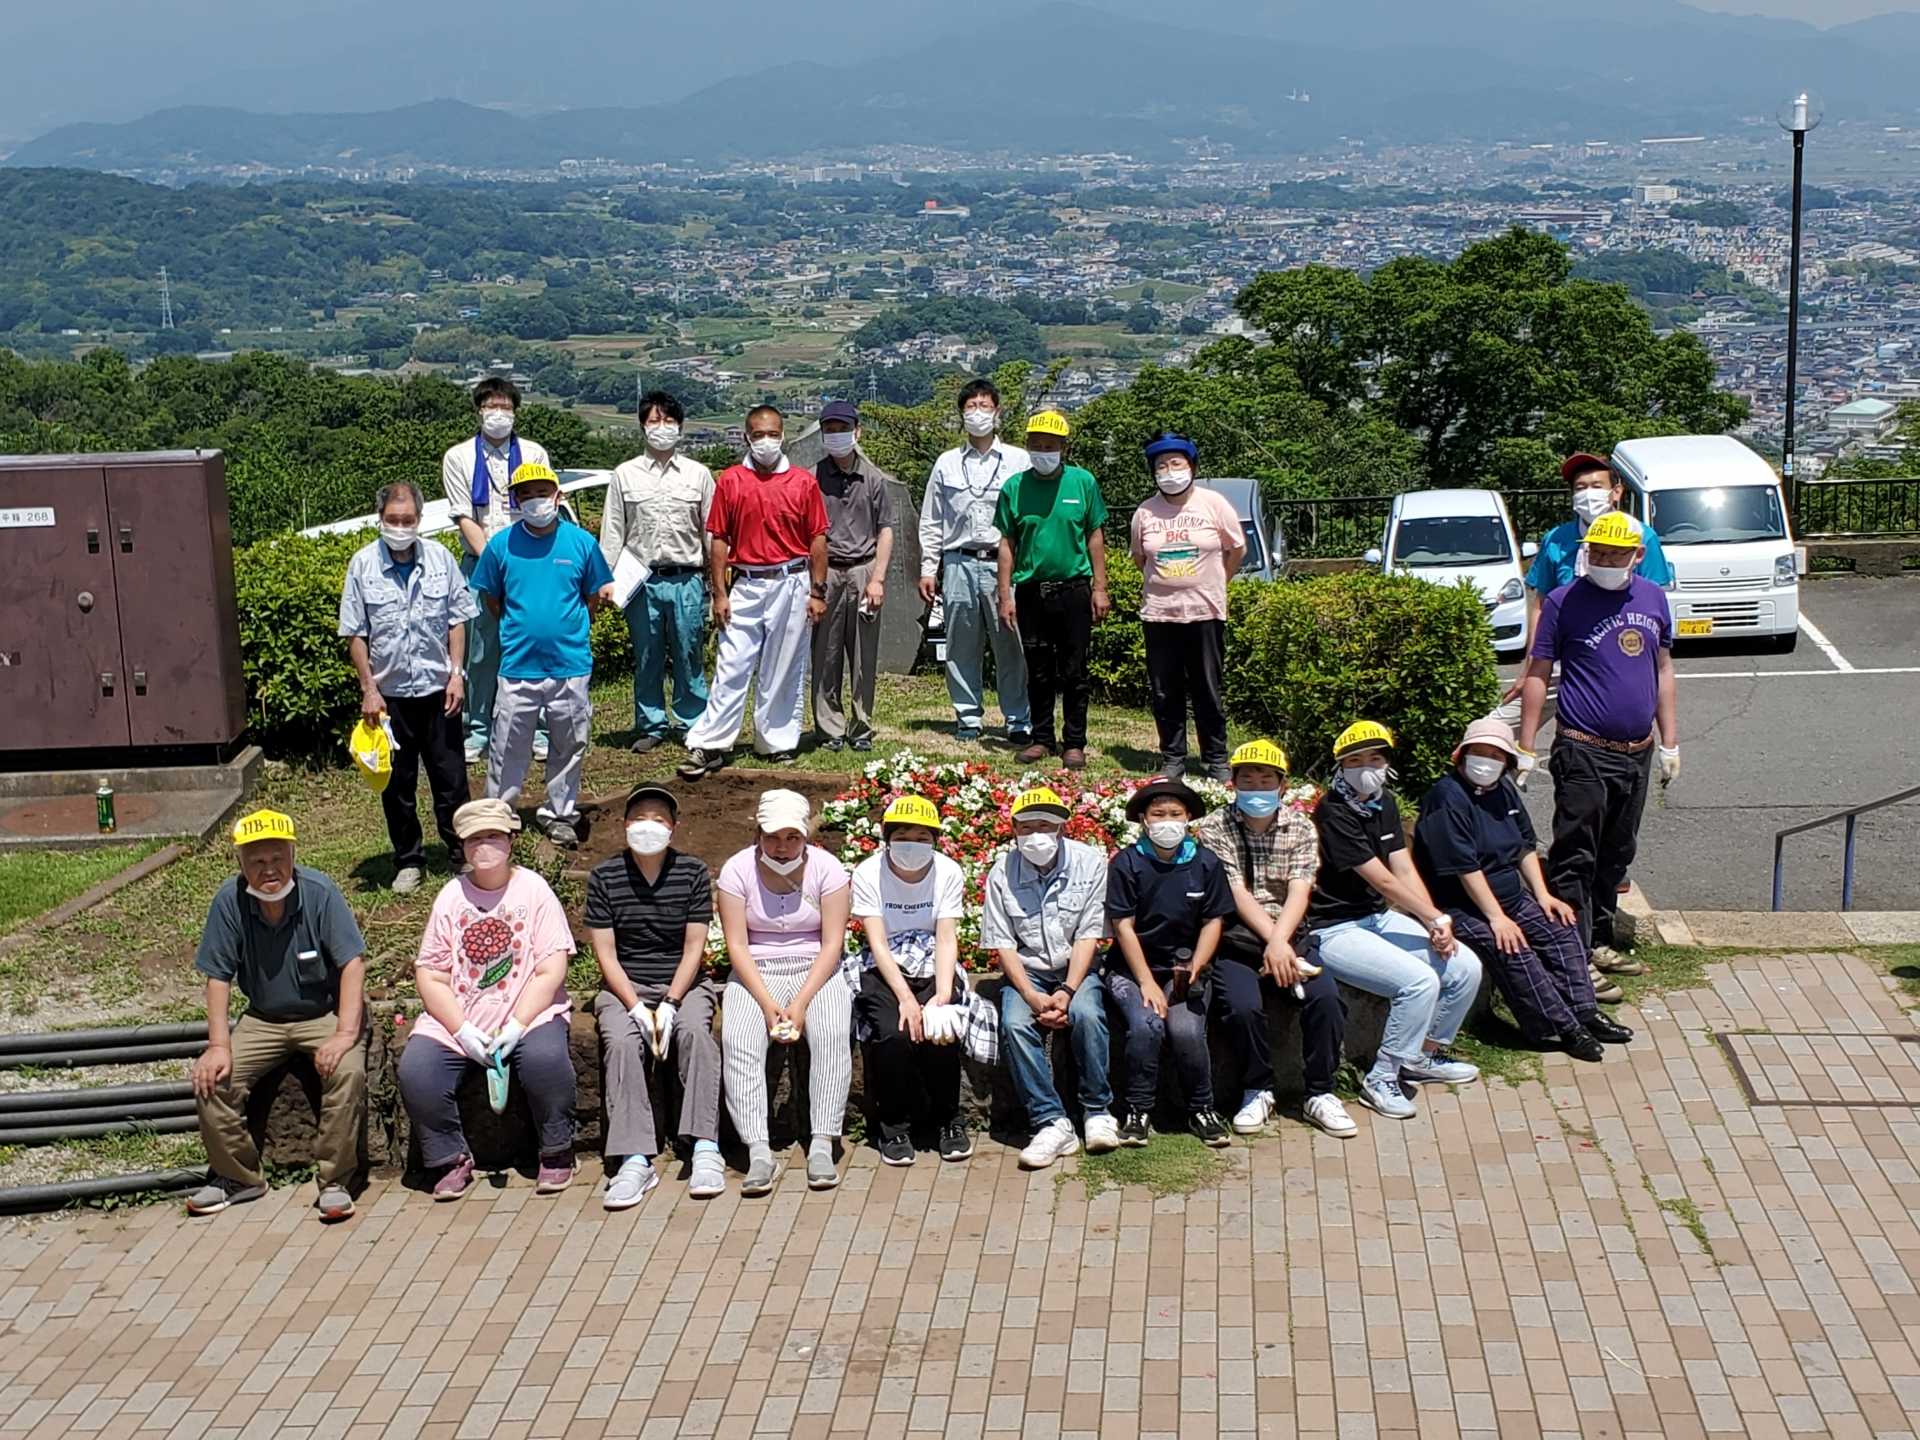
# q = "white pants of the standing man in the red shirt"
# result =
<box><xmin>687</xmin><ymin>568</ymin><xmax>810</xmax><ymax>755</ymax></box>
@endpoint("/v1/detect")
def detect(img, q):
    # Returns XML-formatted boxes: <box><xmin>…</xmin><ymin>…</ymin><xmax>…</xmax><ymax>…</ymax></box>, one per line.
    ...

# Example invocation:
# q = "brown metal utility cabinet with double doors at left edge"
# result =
<box><xmin>0</xmin><ymin>451</ymin><xmax>246</xmax><ymax>762</ymax></box>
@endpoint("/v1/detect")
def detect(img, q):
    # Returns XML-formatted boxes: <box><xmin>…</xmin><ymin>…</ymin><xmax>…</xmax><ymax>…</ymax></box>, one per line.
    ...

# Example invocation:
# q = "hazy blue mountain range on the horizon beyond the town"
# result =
<box><xmin>8</xmin><ymin>0</ymin><xmax>1920</xmax><ymax>175</ymax></box>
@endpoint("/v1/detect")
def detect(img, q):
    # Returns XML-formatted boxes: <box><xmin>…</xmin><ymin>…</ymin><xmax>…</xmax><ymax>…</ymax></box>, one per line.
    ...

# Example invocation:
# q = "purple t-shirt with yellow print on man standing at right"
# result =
<box><xmin>1534</xmin><ymin>576</ymin><xmax>1674</xmax><ymax>743</ymax></box>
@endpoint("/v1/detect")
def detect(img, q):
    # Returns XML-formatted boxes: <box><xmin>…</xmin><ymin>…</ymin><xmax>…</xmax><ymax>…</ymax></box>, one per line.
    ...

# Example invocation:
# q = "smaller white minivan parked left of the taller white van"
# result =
<box><xmin>1365</xmin><ymin>490</ymin><xmax>1540</xmax><ymax>659</ymax></box>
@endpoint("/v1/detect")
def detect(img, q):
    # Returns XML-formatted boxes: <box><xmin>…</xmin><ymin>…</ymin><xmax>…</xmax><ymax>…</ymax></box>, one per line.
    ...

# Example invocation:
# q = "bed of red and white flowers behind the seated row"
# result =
<box><xmin>820</xmin><ymin>751</ymin><xmax>1319</xmax><ymax>972</ymax></box>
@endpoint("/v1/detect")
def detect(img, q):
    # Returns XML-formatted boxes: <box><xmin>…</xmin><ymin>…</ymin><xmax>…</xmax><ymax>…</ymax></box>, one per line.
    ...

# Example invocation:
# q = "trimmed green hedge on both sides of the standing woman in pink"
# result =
<box><xmin>1089</xmin><ymin>553</ymin><xmax>1500</xmax><ymax>793</ymax></box>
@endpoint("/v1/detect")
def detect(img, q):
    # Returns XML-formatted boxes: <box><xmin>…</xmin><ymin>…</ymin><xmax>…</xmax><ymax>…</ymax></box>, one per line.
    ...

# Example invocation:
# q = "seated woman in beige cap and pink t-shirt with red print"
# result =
<box><xmin>399</xmin><ymin>801</ymin><xmax>574</xmax><ymax>1200</ymax></box>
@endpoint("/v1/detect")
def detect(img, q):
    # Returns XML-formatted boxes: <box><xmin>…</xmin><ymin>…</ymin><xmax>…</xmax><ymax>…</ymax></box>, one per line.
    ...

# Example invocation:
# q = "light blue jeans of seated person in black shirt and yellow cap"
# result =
<box><xmin>1315</xmin><ymin>910</ymin><xmax>1480</xmax><ymax>1081</ymax></box>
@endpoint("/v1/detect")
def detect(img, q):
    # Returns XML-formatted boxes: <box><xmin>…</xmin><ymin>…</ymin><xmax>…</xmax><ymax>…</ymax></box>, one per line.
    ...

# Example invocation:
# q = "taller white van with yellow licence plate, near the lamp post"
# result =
<box><xmin>1613</xmin><ymin>436</ymin><xmax>1807</xmax><ymax>651</ymax></box>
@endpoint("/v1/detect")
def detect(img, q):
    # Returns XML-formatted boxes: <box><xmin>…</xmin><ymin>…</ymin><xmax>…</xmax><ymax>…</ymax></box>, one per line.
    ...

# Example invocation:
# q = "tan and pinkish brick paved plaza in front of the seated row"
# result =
<box><xmin>0</xmin><ymin>956</ymin><xmax>1920</xmax><ymax>1440</ymax></box>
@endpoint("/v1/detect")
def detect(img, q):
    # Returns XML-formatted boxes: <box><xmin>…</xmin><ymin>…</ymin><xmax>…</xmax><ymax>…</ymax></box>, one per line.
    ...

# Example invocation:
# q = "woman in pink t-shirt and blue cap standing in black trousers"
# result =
<box><xmin>1129</xmin><ymin>434</ymin><xmax>1246</xmax><ymax>780</ymax></box>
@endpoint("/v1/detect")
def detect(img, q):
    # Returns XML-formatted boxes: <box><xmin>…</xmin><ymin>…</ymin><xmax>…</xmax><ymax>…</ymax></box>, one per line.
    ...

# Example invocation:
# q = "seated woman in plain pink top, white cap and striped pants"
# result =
<box><xmin>714</xmin><ymin>789</ymin><xmax>852</xmax><ymax>1194</ymax></box>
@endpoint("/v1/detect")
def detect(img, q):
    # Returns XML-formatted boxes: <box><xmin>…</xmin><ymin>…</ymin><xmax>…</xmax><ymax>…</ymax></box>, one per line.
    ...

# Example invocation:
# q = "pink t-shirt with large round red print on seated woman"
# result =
<box><xmin>413</xmin><ymin>866</ymin><xmax>574</xmax><ymax>1050</ymax></box>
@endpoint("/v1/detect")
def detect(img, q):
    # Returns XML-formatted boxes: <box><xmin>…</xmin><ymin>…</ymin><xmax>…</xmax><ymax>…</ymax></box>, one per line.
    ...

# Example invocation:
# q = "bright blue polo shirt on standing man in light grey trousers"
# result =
<box><xmin>472</xmin><ymin>518</ymin><xmax>612</xmax><ymax>680</ymax></box>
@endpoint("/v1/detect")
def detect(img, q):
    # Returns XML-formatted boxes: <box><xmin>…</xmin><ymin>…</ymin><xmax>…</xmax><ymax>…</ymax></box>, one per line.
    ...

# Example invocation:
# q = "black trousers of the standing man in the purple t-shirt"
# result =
<box><xmin>1548</xmin><ymin>735</ymin><xmax>1653</xmax><ymax>950</ymax></box>
